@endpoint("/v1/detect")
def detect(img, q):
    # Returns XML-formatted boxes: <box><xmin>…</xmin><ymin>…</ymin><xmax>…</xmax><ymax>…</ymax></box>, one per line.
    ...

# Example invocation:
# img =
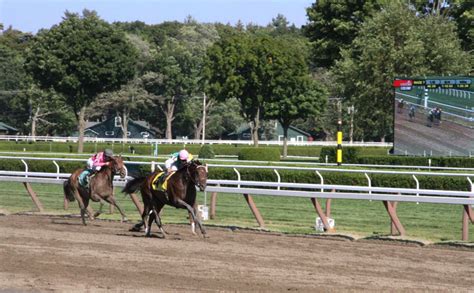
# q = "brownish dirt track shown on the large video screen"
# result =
<box><xmin>395</xmin><ymin>104</ymin><xmax>474</xmax><ymax>156</ymax></box>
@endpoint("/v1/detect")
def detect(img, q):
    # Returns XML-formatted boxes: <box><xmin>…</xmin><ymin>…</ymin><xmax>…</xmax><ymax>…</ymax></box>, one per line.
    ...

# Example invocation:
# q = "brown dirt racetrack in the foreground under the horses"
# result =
<box><xmin>0</xmin><ymin>215</ymin><xmax>474</xmax><ymax>292</ymax></box>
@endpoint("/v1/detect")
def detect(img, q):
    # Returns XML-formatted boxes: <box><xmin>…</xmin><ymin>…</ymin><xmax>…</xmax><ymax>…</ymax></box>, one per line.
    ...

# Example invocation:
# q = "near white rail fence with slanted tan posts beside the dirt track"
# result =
<box><xmin>0</xmin><ymin>157</ymin><xmax>474</xmax><ymax>240</ymax></box>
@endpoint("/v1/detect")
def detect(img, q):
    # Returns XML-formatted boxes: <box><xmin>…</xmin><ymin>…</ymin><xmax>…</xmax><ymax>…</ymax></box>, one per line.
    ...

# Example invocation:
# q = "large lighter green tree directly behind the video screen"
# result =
<box><xmin>333</xmin><ymin>2</ymin><xmax>471</xmax><ymax>141</ymax></box>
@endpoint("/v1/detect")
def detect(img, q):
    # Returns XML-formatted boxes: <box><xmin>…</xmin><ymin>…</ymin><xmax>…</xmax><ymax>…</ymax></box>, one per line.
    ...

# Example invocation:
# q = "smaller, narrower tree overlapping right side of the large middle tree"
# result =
<box><xmin>265</xmin><ymin>38</ymin><xmax>327</xmax><ymax>157</ymax></box>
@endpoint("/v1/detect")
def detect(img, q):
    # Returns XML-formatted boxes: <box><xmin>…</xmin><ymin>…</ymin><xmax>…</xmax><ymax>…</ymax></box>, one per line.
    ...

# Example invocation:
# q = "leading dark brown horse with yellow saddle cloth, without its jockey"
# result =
<box><xmin>122</xmin><ymin>161</ymin><xmax>207</xmax><ymax>237</ymax></box>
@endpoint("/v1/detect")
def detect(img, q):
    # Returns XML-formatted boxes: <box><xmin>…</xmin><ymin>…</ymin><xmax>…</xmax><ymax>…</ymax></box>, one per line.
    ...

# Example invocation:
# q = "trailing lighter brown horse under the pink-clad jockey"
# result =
<box><xmin>64</xmin><ymin>157</ymin><xmax>127</xmax><ymax>225</ymax></box>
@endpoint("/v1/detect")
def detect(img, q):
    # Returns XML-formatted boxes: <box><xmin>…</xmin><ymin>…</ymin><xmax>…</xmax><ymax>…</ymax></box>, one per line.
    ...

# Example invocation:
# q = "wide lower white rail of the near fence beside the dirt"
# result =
<box><xmin>0</xmin><ymin>171</ymin><xmax>474</xmax><ymax>205</ymax></box>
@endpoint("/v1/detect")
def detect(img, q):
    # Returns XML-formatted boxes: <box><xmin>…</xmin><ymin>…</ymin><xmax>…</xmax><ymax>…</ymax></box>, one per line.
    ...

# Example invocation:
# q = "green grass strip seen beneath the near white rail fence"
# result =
<box><xmin>0</xmin><ymin>182</ymin><xmax>474</xmax><ymax>243</ymax></box>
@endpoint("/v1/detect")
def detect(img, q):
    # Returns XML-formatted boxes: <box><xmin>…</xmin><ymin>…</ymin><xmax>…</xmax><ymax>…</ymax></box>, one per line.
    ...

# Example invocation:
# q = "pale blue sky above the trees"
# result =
<box><xmin>0</xmin><ymin>0</ymin><xmax>315</xmax><ymax>33</ymax></box>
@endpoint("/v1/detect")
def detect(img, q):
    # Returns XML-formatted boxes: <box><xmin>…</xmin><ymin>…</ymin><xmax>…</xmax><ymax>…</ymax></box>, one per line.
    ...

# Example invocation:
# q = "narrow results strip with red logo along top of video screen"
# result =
<box><xmin>393</xmin><ymin>79</ymin><xmax>472</xmax><ymax>91</ymax></box>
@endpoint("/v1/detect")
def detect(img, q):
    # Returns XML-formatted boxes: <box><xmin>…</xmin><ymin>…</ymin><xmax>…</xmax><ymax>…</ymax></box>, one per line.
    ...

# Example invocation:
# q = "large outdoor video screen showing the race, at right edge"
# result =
<box><xmin>393</xmin><ymin>76</ymin><xmax>474</xmax><ymax>156</ymax></box>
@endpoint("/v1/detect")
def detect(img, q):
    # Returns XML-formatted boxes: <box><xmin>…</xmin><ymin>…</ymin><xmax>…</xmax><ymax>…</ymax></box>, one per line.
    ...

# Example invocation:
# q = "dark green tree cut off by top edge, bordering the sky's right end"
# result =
<box><xmin>303</xmin><ymin>0</ymin><xmax>379</xmax><ymax>68</ymax></box>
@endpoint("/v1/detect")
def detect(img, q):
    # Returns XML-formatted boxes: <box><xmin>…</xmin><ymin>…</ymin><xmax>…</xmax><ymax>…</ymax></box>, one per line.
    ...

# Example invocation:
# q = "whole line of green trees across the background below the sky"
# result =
<box><xmin>0</xmin><ymin>0</ymin><xmax>474</xmax><ymax>151</ymax></box>
